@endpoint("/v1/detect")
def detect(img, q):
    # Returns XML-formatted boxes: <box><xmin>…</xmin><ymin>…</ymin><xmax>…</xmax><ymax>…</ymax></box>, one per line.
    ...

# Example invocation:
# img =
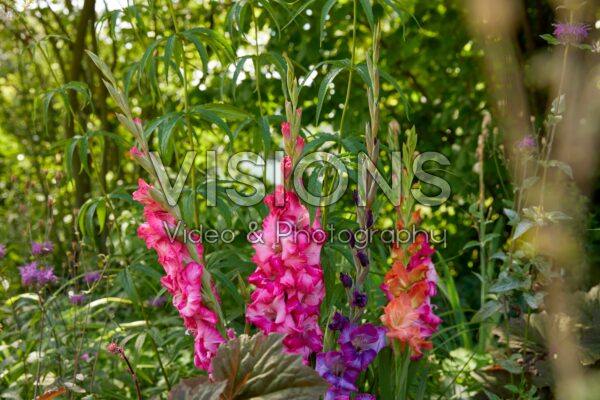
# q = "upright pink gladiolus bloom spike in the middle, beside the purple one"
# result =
<box><xmin>246</xmin><ymin>157</ymin><xmax>327</xmax><ymax>362</ymax></box>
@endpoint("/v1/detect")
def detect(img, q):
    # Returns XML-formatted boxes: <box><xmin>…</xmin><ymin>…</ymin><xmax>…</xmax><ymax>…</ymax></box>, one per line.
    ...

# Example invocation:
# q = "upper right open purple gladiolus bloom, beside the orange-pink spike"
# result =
<box><xmin>338</xmin><ymin>324</ymin><xmax>386</xmax><ymax>371</ymax></box>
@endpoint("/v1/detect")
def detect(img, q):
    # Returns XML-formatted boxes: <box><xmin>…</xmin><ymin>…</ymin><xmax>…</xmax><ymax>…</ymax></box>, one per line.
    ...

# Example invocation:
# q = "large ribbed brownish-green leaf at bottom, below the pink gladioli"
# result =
<box><xmin>212</xmin><ymin>333</ymin><xmax>329</xmax><ymax>400</ymax></box>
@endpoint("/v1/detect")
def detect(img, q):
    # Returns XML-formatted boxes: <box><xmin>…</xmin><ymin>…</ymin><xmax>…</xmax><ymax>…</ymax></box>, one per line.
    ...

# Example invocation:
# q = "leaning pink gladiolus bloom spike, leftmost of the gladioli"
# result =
<box><xmin>133</xmin><ymin>179</ymin><xmax>225</xmax><ymax>372</ymax></box>
